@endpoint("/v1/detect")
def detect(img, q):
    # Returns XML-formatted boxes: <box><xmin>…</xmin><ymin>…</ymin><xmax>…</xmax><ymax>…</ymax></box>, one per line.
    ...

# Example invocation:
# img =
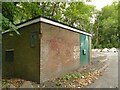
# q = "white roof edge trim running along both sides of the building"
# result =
<box><xmin>2</xmin><ymin>17</ymin><xmax>92</xmax><ymax>36</ymax></box>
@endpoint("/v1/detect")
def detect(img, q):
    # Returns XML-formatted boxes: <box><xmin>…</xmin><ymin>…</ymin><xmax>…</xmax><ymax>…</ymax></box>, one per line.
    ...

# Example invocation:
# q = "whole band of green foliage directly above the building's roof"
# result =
<box><xmin>2</xmin><ymin>2</ymin><xmax>94</xmax><ymax>31</ymax></box>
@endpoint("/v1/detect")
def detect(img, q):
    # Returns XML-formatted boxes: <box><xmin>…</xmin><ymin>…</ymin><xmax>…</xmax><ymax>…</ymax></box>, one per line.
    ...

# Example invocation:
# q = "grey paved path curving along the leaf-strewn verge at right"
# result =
<box><xmin>87</xmin><ymin>52</ymin><xmax>118</xmax><ymax>88</ymax></box>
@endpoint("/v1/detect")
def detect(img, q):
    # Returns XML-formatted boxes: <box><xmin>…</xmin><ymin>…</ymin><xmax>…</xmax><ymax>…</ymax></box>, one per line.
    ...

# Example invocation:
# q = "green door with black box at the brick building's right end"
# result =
<box><xmin>80</xmin><ymin>34</ymin><xmax>89</xmax><ymax>65</ymax></box>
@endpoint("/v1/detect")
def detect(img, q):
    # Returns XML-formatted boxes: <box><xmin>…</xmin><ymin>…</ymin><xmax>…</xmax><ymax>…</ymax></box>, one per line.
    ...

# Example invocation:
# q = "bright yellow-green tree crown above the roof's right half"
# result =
<box><xmin>63</xmin><ymin>2</ymin><xmax>94</xmax><ymax>31</ymax></box>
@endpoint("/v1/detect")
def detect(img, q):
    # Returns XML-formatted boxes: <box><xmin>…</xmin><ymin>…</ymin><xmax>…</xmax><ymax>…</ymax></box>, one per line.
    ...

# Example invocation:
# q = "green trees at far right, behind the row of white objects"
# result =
<box><xmin>93</xmin><ymin>3</ymin><xmax>118</xmax><ymax>48</ymax></box>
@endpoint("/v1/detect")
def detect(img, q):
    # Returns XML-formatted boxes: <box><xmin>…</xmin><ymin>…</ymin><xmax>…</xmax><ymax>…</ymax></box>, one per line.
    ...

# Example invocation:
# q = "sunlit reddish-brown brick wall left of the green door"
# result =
<box><xmin>40</xmin><ymin>23</ymin><xmax>80</xmax><ymax>82</ymax></box>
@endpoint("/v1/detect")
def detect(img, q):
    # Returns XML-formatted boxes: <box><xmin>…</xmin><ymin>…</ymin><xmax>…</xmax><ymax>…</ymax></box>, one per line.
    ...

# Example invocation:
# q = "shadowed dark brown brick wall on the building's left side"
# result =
<box><xmin>2</xmin><ymin>23</ymin><xmax>40</xmax><ymax>82</ymax></box>
